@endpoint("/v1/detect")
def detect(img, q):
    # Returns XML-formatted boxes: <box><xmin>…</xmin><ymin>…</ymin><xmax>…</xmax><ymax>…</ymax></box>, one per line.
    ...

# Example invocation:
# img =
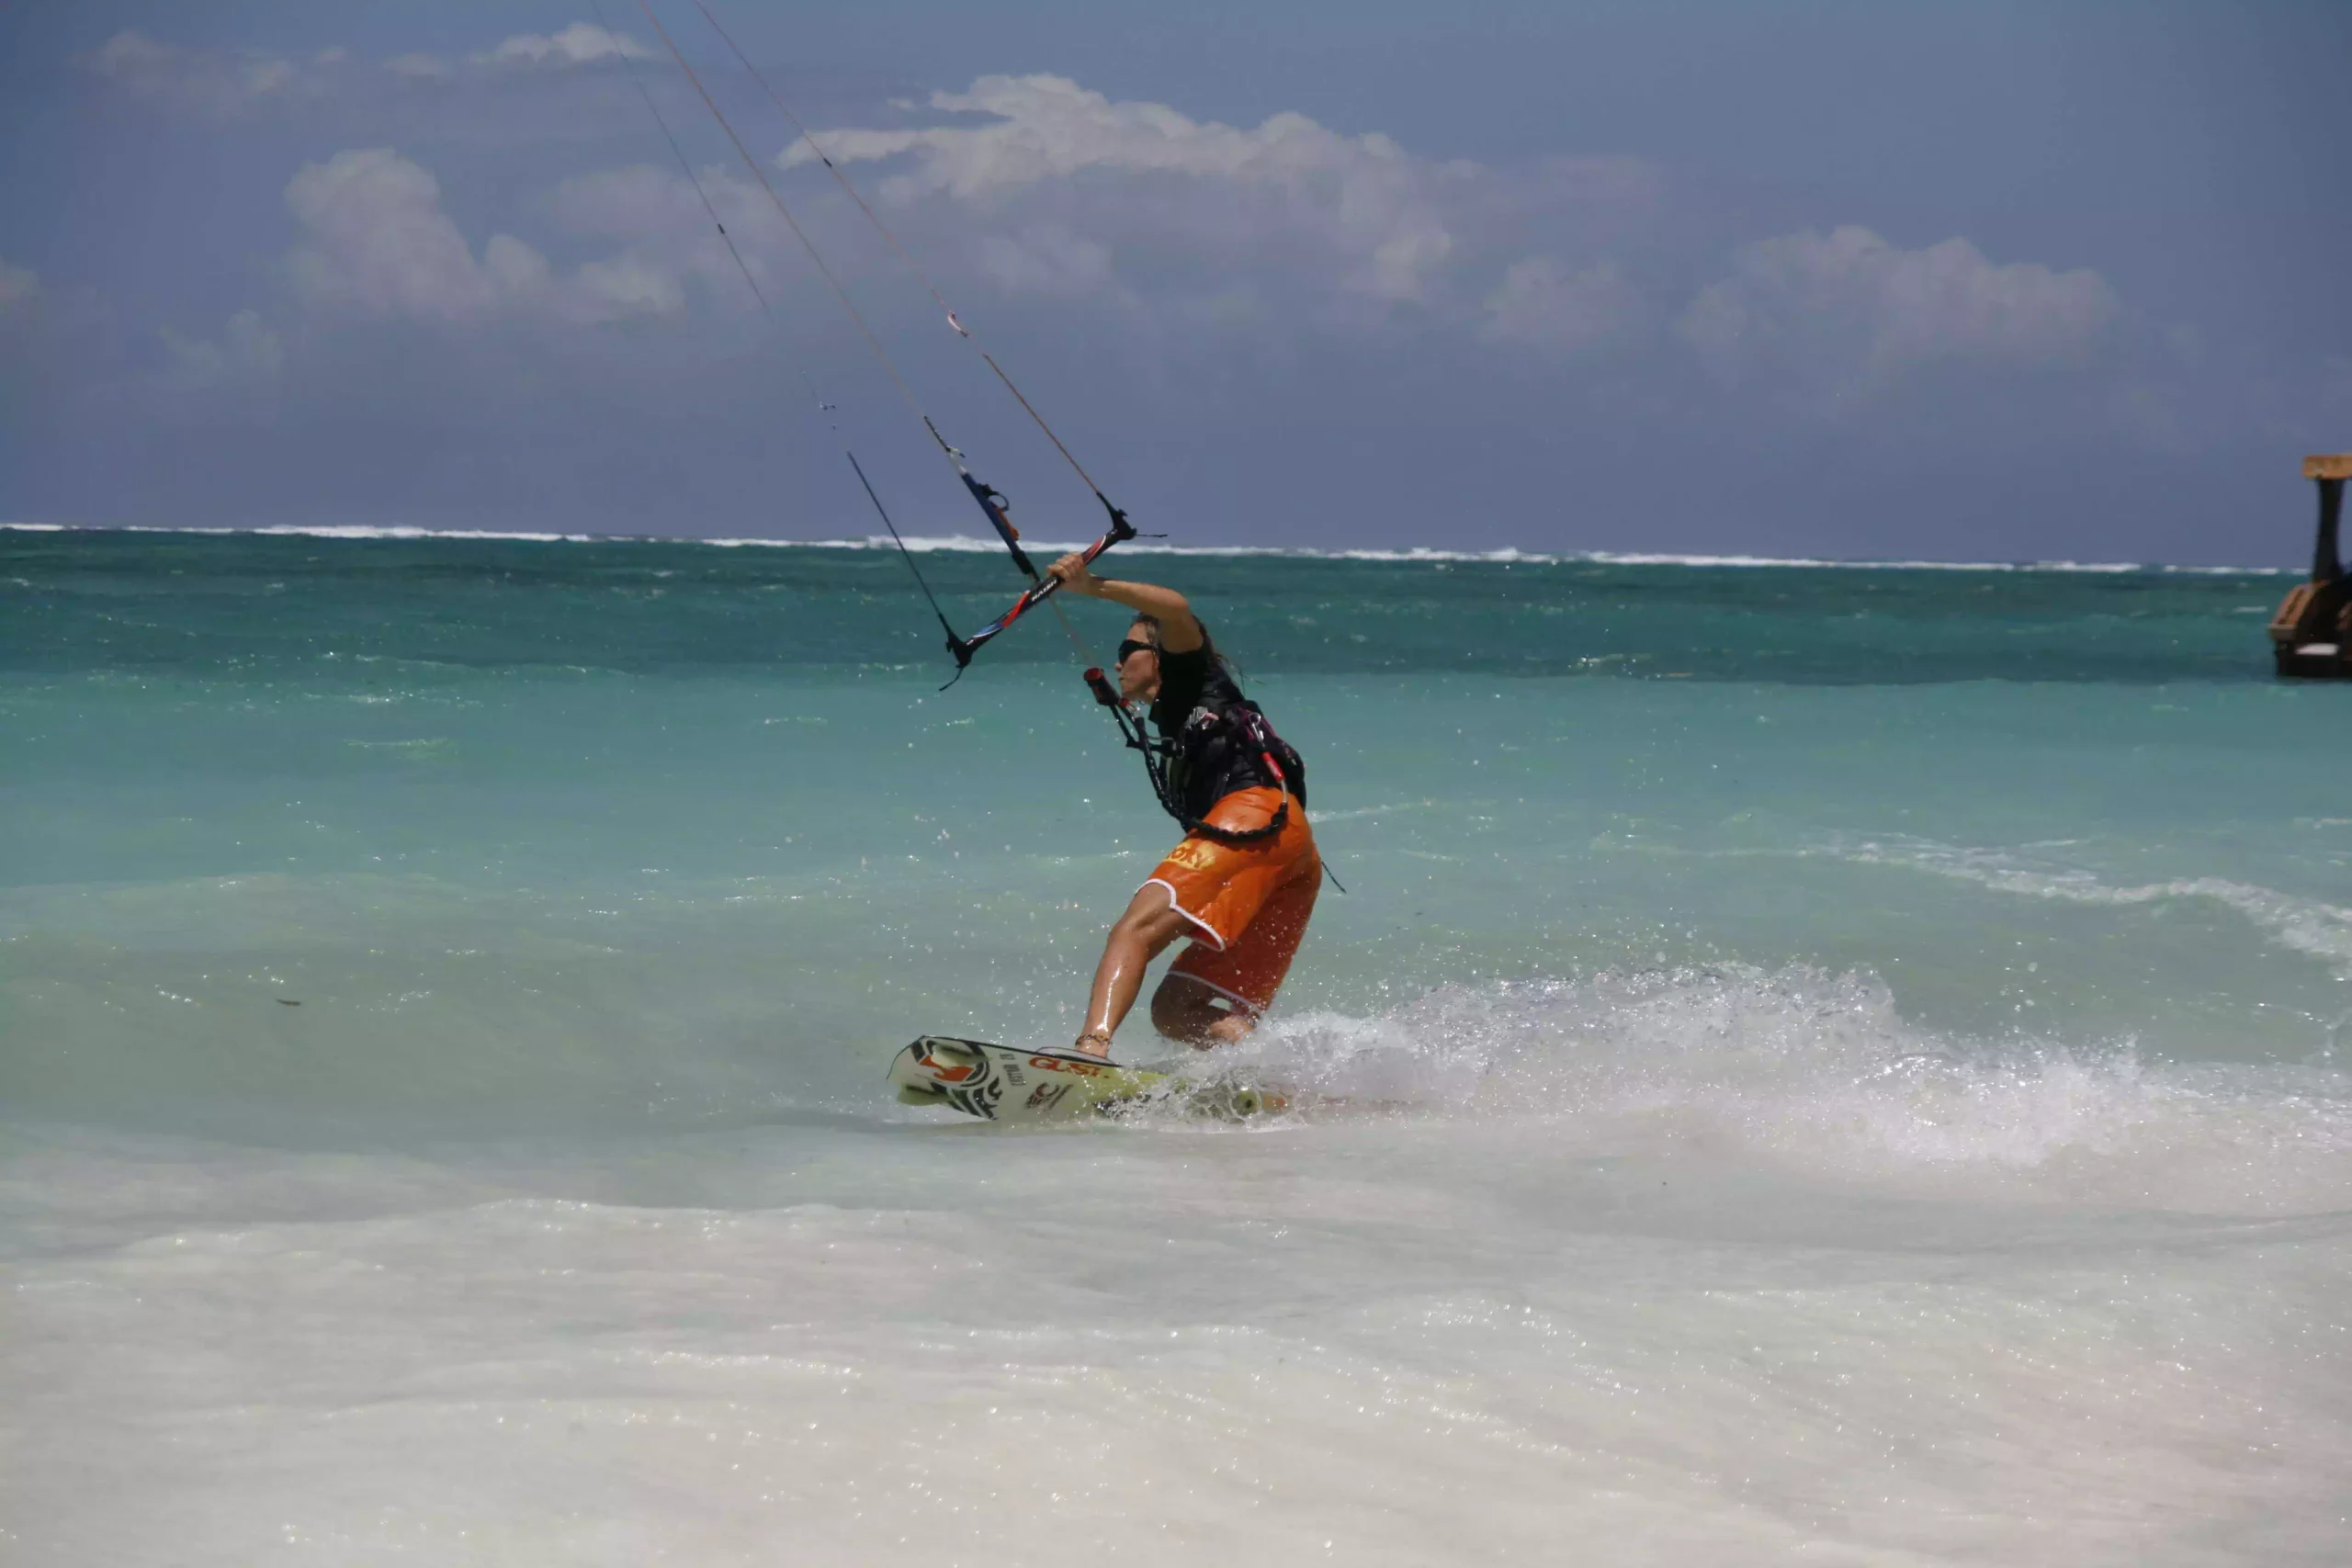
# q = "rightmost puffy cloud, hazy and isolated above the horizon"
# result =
<box><xmin>1677</xmin><ymin>226</ymin><xmax>2124</xmax><ymax>395</ymax></box>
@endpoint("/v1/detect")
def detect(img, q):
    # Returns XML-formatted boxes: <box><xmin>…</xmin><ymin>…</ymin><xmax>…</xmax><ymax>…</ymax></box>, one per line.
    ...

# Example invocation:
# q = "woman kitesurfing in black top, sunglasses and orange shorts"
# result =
<box><xmin>1049</xmin><ymin>552</ymin><xmax>1322</xmax><ymax>1055</ymax></box>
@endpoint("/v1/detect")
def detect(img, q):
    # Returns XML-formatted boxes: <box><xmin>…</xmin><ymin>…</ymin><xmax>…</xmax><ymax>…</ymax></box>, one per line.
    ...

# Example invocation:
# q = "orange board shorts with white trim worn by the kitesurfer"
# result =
<box><xmin>1143</xmin><ymin>787</ymin><xmax>1322</xmax><ymax>1013</ymax></box>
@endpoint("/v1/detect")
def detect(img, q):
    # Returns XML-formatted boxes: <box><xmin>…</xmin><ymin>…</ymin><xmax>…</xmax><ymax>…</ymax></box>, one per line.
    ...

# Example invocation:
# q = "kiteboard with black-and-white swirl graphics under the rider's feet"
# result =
<box><xmin>889</xmin><ymin>1034</ymin><xmax>1289</xmax><ymax>1123</ymax></box>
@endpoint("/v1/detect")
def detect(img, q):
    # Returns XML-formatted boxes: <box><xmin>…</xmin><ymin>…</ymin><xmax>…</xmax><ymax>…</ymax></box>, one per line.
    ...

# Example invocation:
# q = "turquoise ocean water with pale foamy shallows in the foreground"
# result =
<box><xmin>0</xmin><ymin>529</ymin><xmax>2352</xmax><ymax>1563</ymax></box>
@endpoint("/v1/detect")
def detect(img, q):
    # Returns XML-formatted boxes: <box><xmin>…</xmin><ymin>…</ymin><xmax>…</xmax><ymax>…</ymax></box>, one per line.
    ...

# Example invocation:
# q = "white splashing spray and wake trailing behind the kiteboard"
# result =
<box><xmin>1221</xmin><ymin>966</ymin><xmax>2352</xmax><ymax>1213</ymax></box>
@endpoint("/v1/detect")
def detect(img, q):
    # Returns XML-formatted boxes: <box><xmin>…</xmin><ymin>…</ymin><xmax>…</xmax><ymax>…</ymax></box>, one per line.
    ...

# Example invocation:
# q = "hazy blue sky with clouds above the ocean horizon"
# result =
<box><xmin>0</xmin><ymin>0</ymin><xmax>2352</xmax><ymax>564</ymax></box>
